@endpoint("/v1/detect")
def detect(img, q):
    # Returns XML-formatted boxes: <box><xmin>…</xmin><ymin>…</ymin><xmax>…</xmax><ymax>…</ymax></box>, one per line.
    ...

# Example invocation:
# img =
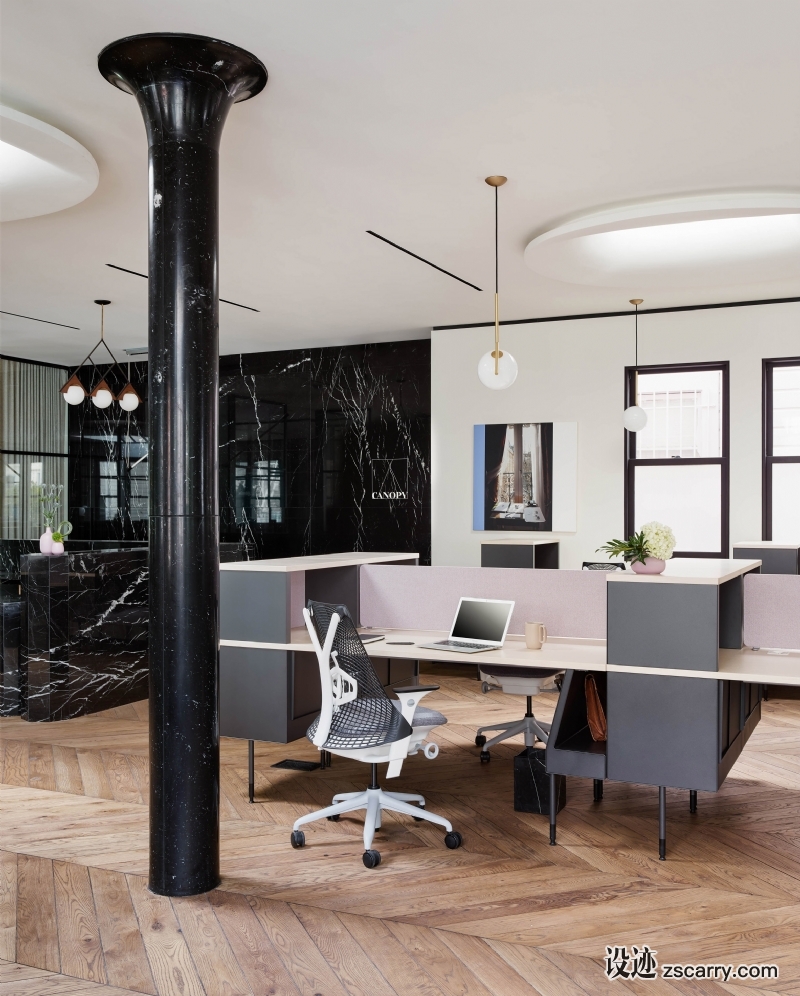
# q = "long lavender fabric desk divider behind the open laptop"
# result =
<box><xmin>360</xmin><ymin>564</ymin><xmax>606</xmax><ymax>639</ymax></box>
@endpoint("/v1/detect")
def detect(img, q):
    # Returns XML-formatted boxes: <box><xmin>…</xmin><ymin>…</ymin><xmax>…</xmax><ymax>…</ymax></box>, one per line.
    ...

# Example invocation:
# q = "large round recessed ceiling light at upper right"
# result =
<box><xmin>525</xmin><ymin>191</ymin><xmax>800</xmax><ymax>289</ymax></box>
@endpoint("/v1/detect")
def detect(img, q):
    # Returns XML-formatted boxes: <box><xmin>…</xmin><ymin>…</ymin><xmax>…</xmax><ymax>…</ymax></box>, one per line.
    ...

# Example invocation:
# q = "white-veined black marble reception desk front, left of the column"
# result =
<box><xmin>19</xmin><ymin>550</ymin><xmax>148</xmax><ymax>722</ymax></box>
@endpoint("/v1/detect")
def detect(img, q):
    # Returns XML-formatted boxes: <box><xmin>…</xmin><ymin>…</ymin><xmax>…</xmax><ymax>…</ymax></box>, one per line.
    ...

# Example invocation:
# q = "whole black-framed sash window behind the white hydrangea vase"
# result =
<box><xmin>625</xmin><ymin>362</ymin><xmax>730</xmax><ymax>557</ymax></box>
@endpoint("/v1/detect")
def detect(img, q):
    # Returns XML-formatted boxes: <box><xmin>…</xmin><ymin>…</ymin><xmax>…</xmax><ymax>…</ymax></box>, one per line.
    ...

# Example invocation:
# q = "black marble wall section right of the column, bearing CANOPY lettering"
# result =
<box><xmin>220</xmin><ymin>339</ymin><xmax>431</xmax><ymax>563</ymax></box>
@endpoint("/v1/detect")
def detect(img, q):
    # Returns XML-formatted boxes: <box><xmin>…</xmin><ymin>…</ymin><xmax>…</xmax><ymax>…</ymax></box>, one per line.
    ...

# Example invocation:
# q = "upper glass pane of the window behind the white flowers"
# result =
<box><xmin>636</xmin><ymin>370</ymin><xmax>722</xmax><ymax>460</ymax></box>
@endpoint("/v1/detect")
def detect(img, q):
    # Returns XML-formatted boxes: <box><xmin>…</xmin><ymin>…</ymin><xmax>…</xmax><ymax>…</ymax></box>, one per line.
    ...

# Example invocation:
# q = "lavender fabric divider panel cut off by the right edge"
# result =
<box><xmin>744</xmin><ymin>574</ymin><xmax>800</xmax><ymax>650</ymax></box>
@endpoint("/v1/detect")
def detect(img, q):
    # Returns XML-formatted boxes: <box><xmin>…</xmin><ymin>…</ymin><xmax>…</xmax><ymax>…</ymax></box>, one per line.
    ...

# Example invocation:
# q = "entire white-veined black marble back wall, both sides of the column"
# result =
<box><xmin>68</xmin><ymin>339</ymin><xmax>431</xmax><ymax>563</ymax></box>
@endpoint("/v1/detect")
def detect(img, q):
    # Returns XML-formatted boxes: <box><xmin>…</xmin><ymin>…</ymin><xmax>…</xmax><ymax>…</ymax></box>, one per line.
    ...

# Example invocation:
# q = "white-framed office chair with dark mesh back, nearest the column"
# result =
<box><xmin>291</xmin><ymin>600</ymin><xmax>461</xmax><ymax>868</ymax></box>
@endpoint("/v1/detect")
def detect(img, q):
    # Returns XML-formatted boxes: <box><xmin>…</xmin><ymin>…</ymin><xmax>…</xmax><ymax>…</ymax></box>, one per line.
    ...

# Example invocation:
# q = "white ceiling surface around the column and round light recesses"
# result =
<box><xmin>0</xmin><ymin>0</ymin><xmax>800</xmax><ymax>364</ymax></box>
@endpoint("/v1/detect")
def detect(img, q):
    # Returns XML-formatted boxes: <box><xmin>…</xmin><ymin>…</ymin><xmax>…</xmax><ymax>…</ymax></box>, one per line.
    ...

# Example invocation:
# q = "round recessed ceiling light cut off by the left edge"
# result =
<box><xmin>0</xmin><ymin>105</ymin><xmax>100</xmax><ymax>221</ymax></box>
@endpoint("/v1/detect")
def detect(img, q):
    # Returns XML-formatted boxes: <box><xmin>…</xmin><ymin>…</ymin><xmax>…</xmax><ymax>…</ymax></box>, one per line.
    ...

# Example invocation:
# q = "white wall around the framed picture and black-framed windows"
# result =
<box><xmin>431</xmin><ymin>303</ymin><xmax>800</xmax><ymax>568</ymax></box>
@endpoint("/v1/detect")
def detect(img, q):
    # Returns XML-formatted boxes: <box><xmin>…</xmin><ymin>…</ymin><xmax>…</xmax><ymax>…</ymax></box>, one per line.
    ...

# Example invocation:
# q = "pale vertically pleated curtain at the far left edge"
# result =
<box><xmin>0</xmin><ymin>359</ymin><xmax>68</xmax><ymax>539</ymax></box>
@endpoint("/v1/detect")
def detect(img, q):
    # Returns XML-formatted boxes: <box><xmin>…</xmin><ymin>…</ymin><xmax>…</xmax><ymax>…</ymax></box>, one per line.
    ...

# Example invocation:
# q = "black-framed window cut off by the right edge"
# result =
<box><xmin>761</xmin><ymin>356</ymin><xmax>800</xmax><ymax>543</ymax></box>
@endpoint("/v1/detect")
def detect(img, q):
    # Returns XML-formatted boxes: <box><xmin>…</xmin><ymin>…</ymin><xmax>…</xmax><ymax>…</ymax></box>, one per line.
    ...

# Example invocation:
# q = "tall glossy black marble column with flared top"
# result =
<box><xmin>98</xmin><ymin>34</ymin><xmax>267</xmax><ymax>896</ymax></box>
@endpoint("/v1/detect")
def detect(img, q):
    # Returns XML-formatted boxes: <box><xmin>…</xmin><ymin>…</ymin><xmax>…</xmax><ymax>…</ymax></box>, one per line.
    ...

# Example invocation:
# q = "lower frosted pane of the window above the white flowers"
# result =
<box><xmin>634</xmin><ymin>464</ymin><xmax>722</xmax><ymax>553</ymax></box>
